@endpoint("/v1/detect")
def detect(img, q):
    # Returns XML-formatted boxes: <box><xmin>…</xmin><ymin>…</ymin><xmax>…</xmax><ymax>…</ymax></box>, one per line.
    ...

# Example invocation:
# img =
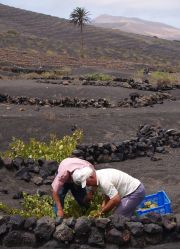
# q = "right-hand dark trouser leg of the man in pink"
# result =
<box><xmin>70</xmin><ymin>183</ymin><xmax>89</xmax><ymax>207</ymax></box>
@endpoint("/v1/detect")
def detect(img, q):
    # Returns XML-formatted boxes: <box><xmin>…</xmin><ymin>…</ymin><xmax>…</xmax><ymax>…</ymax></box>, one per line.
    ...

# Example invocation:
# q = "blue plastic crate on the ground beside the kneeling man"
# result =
<box><xmin>136</xmin><ymin>191</ymin><xmax>172</xmax><ymax>216</ymax></box>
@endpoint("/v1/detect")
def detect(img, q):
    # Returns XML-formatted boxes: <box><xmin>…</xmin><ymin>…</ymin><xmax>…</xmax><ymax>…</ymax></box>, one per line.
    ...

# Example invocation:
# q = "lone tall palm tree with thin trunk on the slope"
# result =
<box><xmin>70</xmin><ymin>7</ymin><xmax>90</xmax><ymax>57</ymax></box>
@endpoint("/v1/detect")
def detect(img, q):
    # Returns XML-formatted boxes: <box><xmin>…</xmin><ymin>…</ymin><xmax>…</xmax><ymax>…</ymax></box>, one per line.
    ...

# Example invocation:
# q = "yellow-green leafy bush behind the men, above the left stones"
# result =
<box><xmin>1</xmin><ymin>130</ymin><xmax>83</xmax><ymax>162</ymax></box>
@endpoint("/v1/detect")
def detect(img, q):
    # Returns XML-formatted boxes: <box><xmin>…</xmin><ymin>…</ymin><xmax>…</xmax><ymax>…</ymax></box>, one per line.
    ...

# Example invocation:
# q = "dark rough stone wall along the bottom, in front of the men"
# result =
<box><xmin>0</xmin><ymin>213</ymin><xmax>180</xmax><ymax>249</ymax></box>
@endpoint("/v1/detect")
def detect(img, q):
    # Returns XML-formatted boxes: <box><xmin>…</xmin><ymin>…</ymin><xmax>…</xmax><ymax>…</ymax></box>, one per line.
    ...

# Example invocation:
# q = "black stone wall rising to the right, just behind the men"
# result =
<box><xmin>73</xmin><ymin>124</ymin><xmax>180</xmax><ymax>163</ymax></box>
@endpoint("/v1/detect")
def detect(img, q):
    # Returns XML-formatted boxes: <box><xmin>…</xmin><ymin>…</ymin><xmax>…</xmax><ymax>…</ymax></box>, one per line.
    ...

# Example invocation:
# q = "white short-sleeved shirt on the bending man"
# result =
<box><xmin>96</xmin><ymin>168</ymin><xmax>141</xmax><ymax>199</ymax></box>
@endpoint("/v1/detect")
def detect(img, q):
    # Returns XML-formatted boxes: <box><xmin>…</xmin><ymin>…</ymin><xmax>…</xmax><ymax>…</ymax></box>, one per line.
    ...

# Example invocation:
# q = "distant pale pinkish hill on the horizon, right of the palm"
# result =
<box><xmin>92</xmin><ymin>15</ymin><xmax>180</xmax><ymax>40</ymax></box>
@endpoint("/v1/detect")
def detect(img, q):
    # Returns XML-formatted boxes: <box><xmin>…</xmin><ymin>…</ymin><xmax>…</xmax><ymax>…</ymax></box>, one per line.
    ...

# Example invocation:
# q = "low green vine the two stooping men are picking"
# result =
<box><xmin>0</xmin><ymin>191</ymin><xmax>106</xmax><ymax>218</ymax></box>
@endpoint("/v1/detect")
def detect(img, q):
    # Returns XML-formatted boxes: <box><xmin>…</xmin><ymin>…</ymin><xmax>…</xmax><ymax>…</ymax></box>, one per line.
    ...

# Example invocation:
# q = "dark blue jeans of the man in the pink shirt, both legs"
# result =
<box><xmin>53</xmin><ymin>183</ymin><xmax>89</xmax><ymax>214</ymax></box>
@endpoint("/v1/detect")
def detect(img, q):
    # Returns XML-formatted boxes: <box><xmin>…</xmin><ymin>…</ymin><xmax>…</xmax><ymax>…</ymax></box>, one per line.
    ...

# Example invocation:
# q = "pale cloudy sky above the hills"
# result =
<box><xmin>0</xmin><ymin>0</ymin><xmax>180</xmax><ymax>28</ymax></box>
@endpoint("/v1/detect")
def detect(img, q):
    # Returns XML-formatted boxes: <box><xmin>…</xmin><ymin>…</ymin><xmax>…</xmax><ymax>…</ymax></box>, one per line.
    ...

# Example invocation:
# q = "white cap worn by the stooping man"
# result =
<box><xmin>72</xmin><ymin>167</ymin><xmax>93</xmax><ymax>188</ymax></box>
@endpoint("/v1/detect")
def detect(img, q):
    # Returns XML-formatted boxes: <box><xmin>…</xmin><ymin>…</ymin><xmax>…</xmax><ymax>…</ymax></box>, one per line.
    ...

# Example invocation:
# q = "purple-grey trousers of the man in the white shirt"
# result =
<box><xmin>114</xmin><ymin>184</ymin><xmax>145</xmax><ymax>217</ymax></box>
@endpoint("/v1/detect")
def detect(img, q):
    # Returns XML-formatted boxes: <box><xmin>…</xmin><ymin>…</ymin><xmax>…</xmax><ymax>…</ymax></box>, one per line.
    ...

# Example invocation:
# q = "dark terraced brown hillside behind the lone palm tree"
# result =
<box><xmin>0</xmin><ymin>4</ymin><xmax>180</xmax><ymax>71</ymax></box>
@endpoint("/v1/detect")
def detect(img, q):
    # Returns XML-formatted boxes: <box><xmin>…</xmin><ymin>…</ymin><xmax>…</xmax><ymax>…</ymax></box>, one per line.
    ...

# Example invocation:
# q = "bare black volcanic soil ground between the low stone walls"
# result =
<box><xmin>0</xmin><ymin>80</ymin><xmax>180</xmax><ymax>249</ymax></box>
